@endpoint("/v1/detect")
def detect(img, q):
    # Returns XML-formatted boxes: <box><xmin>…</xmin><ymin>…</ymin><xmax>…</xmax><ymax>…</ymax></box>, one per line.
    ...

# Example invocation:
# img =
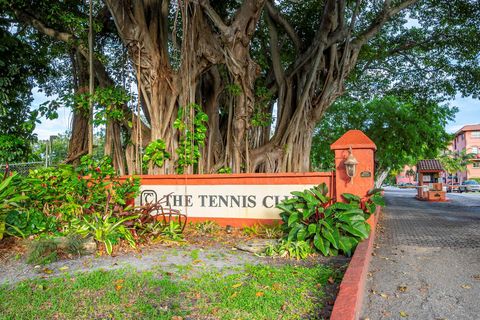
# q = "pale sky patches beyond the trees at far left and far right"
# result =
<box><xmin>32</xmin><ymin>89</ymin><xmax>480</xmax><ymax>140</ymax></box>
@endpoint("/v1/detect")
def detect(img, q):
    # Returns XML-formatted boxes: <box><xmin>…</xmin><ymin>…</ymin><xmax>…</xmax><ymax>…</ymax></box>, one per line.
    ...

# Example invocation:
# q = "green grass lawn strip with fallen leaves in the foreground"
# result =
<box><xmin>0</xmin><ymin>265</ymin><xmax>340</xmax><ymax>320</ymax></box>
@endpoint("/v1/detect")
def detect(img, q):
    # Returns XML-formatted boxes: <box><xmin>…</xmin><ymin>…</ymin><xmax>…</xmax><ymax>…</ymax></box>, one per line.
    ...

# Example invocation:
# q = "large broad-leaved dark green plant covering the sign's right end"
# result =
<box><xmin>277</xmin><ymin>184</ymin><xmax>383</xmax><ymax>257</ymax></box>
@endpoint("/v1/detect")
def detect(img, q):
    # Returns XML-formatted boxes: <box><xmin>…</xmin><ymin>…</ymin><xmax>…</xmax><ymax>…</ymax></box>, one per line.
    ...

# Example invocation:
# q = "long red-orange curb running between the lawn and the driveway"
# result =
<box><xmin>330</xmin><ymin>207</ymin><xmax>381</xmax><ymax>320</ymax></box>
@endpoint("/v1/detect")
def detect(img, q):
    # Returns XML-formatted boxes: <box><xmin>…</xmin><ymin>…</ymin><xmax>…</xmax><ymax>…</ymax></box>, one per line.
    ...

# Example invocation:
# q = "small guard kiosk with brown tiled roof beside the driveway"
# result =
<box><xmin>417</xmin><ymin>160</ymin><xmax>447</xmax><ymax>201</ymax></box>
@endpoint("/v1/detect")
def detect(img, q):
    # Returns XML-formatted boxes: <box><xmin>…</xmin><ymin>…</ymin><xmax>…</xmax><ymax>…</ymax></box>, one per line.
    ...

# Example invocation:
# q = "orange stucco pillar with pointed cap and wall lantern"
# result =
<box><xmin>330</xmin><ymin>130</ymin><xmax>377</xmax><ymax>202</ymax></box>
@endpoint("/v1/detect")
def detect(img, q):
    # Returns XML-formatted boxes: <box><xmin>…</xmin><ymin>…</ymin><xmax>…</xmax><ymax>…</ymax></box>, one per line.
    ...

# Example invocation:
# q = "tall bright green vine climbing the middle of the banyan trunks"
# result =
<box><xmin>173</xmin><ymin>103</ymin><xmax>208</xmax><ymax>174</ymax></box>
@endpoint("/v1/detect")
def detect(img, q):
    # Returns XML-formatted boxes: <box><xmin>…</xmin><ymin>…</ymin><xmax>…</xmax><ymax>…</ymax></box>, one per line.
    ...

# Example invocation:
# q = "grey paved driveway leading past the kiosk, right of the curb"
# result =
<box><xmin>362</xmin><ymin>190</ymin><xmax>480</xmax><ymax>320</ymax></box>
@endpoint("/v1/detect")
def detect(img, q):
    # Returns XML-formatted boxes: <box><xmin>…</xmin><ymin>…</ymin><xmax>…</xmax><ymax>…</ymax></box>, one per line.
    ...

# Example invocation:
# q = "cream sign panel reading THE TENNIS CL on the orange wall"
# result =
<box><xmin>137</xmin><ymin>184</ymin><xmax>314</xmax><ymax>219</ymax></box>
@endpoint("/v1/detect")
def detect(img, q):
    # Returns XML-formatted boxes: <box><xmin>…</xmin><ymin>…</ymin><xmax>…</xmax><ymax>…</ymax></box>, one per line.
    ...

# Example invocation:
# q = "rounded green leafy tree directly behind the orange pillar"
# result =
<box><xmin>311</xmin><ymin>96</ymin><xmax>457</xmax><ymax>173</ymax></box>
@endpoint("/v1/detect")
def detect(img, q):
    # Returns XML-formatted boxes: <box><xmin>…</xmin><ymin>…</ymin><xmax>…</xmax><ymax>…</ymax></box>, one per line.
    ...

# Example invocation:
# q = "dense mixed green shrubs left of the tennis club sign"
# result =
<box><xmin>6</xmin><ymin>156</ymin><xmax>139</xmax><ymax>254</ymax></box>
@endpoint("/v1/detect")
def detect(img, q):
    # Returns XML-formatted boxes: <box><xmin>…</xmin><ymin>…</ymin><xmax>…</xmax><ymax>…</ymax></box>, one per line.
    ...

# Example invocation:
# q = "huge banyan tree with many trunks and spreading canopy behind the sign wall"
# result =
<box><xmin>0</xmin><ymin>0</ymin><xmax>480</xmax><ymax>173</ymax></box>
